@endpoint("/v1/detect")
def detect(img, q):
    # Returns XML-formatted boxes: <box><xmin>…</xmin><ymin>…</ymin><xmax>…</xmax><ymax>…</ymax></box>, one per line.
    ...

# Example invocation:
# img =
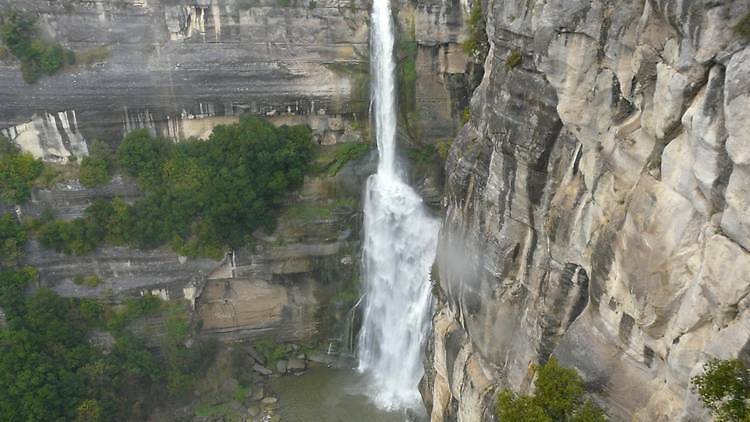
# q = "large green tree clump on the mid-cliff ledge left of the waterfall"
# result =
<box><xmin>37</xmin><ymin>117</ymin><xmax>314</xmax><ymax>258</ymax></box>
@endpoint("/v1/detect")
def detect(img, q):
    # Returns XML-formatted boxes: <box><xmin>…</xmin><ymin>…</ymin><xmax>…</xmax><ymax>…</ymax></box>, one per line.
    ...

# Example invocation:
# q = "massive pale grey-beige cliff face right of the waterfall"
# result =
<box><xmin>423</xmin><ymin>0</ymin><xmax>750</xmax><ymax>421</ymax></box>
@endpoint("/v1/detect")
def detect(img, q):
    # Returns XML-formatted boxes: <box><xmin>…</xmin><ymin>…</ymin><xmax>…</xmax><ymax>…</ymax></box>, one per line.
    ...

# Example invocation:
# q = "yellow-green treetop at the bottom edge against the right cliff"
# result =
<box><xmin>496</xmin><ymin>358</ymin><xmax>607</xmax><ymax>422</ymax></box>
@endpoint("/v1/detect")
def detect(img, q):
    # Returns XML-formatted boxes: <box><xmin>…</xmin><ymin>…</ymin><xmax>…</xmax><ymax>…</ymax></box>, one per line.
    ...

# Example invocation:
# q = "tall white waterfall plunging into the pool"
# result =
<box><xmin>359</xmin><ymin>0</ymin><xmax>440</xmax><ymax>409</ymax></box>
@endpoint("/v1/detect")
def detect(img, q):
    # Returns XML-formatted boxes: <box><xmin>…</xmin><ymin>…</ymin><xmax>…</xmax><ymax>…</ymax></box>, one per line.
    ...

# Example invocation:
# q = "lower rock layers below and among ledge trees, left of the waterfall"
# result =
<box><xmin>20</xmin><ymin>145</ymin><xmax>376</xmax><ymax>347</ymax></box>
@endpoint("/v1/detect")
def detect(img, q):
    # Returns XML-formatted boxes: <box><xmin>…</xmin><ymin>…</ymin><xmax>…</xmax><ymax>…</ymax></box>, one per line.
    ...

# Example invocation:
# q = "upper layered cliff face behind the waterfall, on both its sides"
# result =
<box><xmin>0</xmin><ymin>0</ymin><xmax>467</xmax><ymax>161</ymax></box>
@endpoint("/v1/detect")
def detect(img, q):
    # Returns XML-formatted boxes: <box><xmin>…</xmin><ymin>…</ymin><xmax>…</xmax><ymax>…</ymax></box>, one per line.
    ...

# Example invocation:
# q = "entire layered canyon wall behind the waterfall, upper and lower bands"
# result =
<box><xmin>0</xmin><ymin>0</ymin><xmax>468</xmax><ymax>348</ymax></box>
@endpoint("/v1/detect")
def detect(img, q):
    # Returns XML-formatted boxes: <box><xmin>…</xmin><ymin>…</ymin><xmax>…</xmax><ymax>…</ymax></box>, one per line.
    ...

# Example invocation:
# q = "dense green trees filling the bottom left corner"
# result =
<box><xmin>0</xmin><ymin>269</ymin><xmax>217</xmax><ymax>422</ymax></box>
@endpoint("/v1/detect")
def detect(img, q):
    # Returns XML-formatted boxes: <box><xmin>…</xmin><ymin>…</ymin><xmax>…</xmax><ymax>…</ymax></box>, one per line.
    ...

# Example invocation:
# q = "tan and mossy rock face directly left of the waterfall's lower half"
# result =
<box><xmin>196</xmin><ymin>152</ymin><xmax>375</xmax><ymax>342</ymax></box>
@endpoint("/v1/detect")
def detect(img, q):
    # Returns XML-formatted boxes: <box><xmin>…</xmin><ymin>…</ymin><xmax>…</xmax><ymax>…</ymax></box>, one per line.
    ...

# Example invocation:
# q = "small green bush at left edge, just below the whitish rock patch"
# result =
<box><xmin>0</xmin><ymin>136</ymin><xmax>44</xmax><ymax>204</ymax></box>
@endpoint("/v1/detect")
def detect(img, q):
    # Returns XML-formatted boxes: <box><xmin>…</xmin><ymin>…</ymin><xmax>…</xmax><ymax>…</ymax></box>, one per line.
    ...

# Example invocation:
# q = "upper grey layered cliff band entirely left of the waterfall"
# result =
<box><xmin>0</xmin><ymin>0</ymin><xmax>374</xmax><ymax>148</ymax></box>
